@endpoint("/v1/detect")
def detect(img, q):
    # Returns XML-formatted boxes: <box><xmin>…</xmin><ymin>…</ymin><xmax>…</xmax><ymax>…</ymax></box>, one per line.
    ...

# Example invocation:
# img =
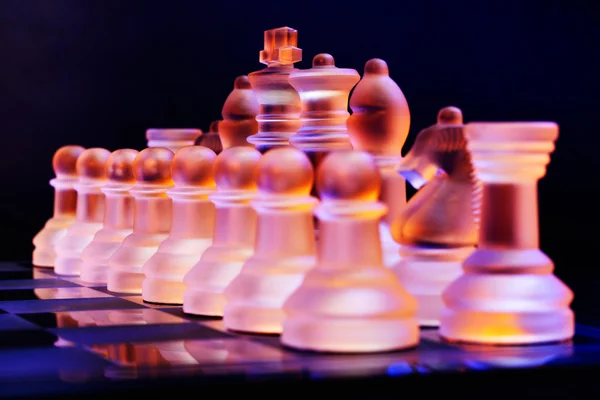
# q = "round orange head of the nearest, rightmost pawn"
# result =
<box><xmin>317</xmin><ymin>151</ymin><xmax>381</xmax><ymax>201</ymax></box>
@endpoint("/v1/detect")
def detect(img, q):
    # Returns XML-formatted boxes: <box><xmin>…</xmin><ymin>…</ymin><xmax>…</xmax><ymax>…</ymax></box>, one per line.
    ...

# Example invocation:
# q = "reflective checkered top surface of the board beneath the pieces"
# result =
<box><xmin>0</xmin><ymin>262</ymin><xmax>600</xmax><ymax>394</ymax></box>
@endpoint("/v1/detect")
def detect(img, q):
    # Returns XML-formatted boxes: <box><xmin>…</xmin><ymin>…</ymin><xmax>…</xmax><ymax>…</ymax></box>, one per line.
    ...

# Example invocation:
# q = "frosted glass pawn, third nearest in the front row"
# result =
<box><xmin>183</xmin><ymin>146</ymin><xmax>261</xmax><ymax>317</ymax></box>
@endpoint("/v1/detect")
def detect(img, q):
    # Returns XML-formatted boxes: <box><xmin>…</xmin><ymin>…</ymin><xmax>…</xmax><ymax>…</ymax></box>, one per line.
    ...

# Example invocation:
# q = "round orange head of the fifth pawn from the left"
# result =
<box><xmin>171</xmin><ymin>146</ymin><xmax>217</xmax><ymax>187</ymax></box>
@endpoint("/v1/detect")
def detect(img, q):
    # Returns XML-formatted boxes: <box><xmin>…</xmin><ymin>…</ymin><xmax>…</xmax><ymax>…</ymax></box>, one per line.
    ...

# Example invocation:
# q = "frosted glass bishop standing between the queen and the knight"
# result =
<box><xmin>347</xmin><ymin>58</ymin><xmax>410</xmax><ymax>268</ymax></box>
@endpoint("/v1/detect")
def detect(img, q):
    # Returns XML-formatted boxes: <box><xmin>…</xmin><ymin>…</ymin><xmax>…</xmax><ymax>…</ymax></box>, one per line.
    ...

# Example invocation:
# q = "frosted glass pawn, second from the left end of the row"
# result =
<box><xmin>54</xmin><ymin>148</ymin><xmax>110</xmax><ymax>276</ymax></box>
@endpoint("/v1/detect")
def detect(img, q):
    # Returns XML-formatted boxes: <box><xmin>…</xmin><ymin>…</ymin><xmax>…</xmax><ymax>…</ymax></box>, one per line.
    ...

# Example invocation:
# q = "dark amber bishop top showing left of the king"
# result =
<box><xmin>218</xmin><ymin>75</ymin><xmax>258</xmax><ymax>149</ymax></box>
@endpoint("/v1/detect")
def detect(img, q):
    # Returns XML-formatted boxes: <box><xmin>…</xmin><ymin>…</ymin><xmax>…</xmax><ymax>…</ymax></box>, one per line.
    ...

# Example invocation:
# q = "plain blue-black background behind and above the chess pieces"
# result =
<box><xmin>0</xmin><ymin>0</ymin><xmax>600</xmax><ymax>306</ymax></box>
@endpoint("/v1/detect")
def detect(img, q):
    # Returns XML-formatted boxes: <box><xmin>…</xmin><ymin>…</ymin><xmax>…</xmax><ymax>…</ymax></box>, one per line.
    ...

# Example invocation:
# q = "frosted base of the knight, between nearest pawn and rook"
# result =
<box><xmin>393</xmin><ymin>245</ymin><xmax>475</xmax><ymax>327</ymax></box>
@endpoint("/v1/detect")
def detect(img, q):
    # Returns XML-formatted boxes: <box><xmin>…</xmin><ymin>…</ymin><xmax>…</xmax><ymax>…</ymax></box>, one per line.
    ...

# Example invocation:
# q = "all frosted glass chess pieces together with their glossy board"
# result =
<box><xmin>0</xmin><ymin>27</ymin><xmax>600</xmax><ymax>398</ymax></box>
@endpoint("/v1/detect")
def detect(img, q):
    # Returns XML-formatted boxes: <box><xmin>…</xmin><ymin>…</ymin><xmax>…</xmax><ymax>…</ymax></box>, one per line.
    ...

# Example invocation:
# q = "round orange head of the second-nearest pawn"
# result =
<box><xmin>257</xmin><ymin>146</ymin><xmax>314</xmax><ymax>196</ymax></box>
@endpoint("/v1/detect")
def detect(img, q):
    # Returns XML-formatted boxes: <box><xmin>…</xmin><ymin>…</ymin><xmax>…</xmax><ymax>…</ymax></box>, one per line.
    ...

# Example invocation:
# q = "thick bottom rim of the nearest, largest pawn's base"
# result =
<box><xmin>281</xmin><ymin>317</ymin><xmax>419</xmax><ymax>353</ymax></box>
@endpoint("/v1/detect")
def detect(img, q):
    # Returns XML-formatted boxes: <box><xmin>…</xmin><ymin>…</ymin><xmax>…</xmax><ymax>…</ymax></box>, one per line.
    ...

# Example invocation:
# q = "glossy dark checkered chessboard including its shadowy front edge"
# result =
<box><xmin>0</xmin><ymin>262</ymin><xmax>600</xmax><ymax>399</ymax></box>
